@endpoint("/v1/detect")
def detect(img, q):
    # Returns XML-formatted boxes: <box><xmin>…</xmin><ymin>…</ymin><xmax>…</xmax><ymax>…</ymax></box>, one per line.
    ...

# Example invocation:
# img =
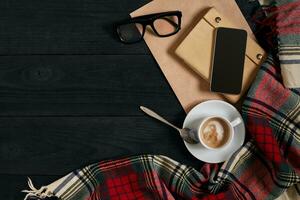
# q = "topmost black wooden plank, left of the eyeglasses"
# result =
<box><xmin>0</xmin><ymin>0</ymin><xmax>149</xmax><ymax>55</ymax></box>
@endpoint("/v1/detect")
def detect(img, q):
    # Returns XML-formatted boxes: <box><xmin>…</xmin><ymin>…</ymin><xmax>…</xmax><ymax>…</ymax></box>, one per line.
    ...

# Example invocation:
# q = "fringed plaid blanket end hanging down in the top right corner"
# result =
<box><xmin>259</xmin><ymin>0</ymin><xmax>300</xmax><ymax>88</ymax></box>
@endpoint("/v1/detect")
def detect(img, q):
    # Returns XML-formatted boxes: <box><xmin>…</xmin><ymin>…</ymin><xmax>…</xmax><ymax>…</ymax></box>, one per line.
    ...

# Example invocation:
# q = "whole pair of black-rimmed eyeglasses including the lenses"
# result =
<box><xmin>117</xmin><ymin>11</ymin><xmax>182</xmax><ymax>44</ymax></box>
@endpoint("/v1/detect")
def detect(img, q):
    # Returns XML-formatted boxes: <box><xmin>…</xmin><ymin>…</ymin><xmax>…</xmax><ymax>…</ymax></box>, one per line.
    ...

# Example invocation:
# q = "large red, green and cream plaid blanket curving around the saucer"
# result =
<box><xmin>24</xmin><ymin>0</ymin><xmax>300</xmax><ymax>200</ymax></box>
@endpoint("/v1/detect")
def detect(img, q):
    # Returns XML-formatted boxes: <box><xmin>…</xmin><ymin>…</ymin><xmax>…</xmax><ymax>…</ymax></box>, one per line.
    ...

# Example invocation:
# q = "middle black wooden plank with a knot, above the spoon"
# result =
<box><xmin>0</xmin><ymin>55</ymin><xmax>183</xmax><ymax>116</ymax></box>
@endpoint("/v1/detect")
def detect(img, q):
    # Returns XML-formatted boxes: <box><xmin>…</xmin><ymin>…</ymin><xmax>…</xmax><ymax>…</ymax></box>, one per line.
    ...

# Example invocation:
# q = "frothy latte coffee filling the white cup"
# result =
<box><xmin>199</xmin><ymin>117</ymin><xmax>231</xmax><ymax>148</ymax></box>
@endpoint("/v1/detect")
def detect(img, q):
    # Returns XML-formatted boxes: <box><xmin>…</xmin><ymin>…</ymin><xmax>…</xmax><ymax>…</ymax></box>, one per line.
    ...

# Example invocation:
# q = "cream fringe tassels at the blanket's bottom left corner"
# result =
<box><xmin>22</xmin><ymin>177</ymin><xmax>54</xmax><ymax>200</ymax></box>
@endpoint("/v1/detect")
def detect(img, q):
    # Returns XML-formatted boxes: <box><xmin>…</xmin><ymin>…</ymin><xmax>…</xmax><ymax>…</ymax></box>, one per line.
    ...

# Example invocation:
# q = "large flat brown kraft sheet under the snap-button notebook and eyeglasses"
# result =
<box><xmin>130</xmin><ymin>0</ymin><xmax>264</xmax><ymax>112</ymax></box>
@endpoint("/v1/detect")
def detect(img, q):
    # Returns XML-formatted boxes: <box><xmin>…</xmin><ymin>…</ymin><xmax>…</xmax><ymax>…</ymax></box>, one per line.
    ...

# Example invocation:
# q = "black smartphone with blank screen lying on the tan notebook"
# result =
<box><xmin>210</xmin><ymin>27</ymin><xmax>247</xmax><ymax>94</ymax></box>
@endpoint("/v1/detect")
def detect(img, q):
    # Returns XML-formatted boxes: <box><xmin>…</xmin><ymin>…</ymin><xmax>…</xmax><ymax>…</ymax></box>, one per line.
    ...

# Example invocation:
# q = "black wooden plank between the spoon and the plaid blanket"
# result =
<box><xmin>0</xmin><ymin>116</ymin><xmax>201</xmax><ymax>175</ymax></box>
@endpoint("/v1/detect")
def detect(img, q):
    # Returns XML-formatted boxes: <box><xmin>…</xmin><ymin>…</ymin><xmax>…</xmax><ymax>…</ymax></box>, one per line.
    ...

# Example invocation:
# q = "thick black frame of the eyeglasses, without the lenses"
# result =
<box><xmin>117</xmin><ymin>10</ymin><xmax>182</xmax><ymax>44</ymax></box>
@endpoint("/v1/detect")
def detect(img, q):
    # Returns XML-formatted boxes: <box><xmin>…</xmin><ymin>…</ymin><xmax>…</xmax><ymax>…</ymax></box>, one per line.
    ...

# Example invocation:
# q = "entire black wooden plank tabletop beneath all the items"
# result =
<box><xmin>0</xmin><ymin>0</ymin><xmax>257</xmax><ymax>200</ymax></box>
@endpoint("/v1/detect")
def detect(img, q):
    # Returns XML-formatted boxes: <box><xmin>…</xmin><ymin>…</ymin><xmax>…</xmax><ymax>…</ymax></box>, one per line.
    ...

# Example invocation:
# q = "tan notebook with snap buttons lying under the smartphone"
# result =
<box><xmin>175</xmin><ymin>8</ymin><xmax>265</xmax><ymax>103</ymax></box>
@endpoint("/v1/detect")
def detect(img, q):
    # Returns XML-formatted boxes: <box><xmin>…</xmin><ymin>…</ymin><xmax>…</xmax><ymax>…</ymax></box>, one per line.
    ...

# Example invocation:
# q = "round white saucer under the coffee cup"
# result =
<box><xmin>183</xmin><ymin>100</ymin><xmax>245</xmax><ymax>163</ymax></box>
